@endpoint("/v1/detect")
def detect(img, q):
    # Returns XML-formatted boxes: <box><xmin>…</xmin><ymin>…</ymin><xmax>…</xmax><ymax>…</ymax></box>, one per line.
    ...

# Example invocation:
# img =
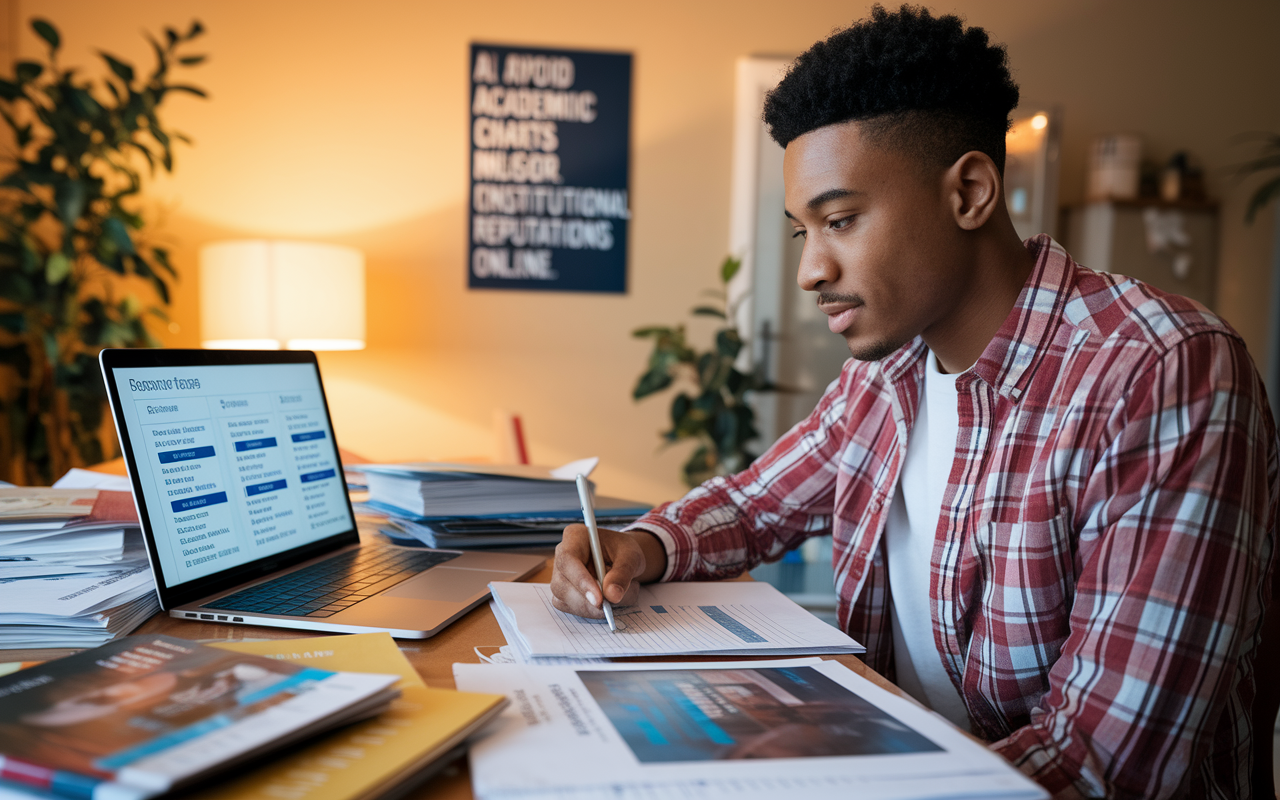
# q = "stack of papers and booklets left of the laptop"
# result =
<box><xmin>0</xmin><ymin>488</ymin><xmax>160</xmax><ymax>649</ymax></box>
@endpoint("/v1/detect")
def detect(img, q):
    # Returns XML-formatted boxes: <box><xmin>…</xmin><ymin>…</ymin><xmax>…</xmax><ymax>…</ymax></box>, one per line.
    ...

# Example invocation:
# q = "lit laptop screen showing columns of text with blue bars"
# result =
<box><xmin>114</xmin><ymin>364</ymin><xmax>355</xmax><ymax>586</ymax></box>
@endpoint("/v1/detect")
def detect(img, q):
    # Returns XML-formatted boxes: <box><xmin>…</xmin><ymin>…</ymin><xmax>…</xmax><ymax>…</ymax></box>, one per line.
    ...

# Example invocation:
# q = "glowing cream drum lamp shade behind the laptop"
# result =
<box><xmin>200</xmin><ymin>239</ymin><xmax>365</xmax><ymax>349</ymax></box>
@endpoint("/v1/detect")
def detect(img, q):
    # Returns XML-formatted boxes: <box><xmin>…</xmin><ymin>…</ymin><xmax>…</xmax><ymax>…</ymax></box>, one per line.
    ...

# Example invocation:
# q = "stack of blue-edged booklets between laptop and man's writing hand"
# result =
<box><xmin>358</xmin><ymin>458</ymin><xmax>649</xmax><ymax>548</ymax></box>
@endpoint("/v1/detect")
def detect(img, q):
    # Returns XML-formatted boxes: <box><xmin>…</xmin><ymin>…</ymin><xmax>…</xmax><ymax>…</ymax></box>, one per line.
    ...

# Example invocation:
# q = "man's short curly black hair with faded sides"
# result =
<box><xmin>764</xmin><ymin>4</ymin><xmax>1018</xmax><ymax>173</ymax></box>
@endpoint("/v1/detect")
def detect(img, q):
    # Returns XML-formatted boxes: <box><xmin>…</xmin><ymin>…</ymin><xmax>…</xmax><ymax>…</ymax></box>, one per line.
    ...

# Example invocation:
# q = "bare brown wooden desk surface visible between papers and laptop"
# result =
<box><xmin>0</xmin><ymin>559</ymin><xmax>906</xmax><ymax>800</ymax></box>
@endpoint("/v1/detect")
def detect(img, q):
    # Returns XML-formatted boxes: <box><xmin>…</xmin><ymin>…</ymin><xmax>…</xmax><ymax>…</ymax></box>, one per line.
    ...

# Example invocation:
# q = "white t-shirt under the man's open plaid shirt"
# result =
<box><xmin>884</xmin><ymin>352</ymin><xmax>969</xmax><ymax>731</ymax></box>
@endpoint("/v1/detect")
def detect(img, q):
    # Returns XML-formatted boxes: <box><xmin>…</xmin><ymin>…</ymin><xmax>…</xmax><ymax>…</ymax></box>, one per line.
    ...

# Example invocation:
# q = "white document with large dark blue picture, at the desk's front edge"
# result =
<box><xmin>453</xmin><ymin>659</ymin><xmax>1047</xmax><ymax>800</ymax></box>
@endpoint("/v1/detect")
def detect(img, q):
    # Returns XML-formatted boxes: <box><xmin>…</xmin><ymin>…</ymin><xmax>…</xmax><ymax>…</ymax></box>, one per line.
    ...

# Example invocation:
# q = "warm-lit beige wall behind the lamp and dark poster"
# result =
<box><xmin>8</xmin><ymin>0</ymin><xmax>1280</xmax><ymax>500</ymax></box>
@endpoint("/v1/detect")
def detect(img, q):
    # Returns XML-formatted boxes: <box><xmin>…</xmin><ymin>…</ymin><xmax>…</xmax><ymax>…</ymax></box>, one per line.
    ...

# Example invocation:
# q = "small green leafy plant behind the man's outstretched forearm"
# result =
<box><xmin>631</xmin><ymin>257</ymin><xmax>759</xmax><ymax>486</ymax></box>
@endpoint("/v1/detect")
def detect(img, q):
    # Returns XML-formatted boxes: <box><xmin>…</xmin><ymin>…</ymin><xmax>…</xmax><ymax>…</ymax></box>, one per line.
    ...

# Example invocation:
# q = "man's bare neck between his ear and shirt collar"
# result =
<box><xmin>924</xmin><ymin>223</ymin><xmax>1036</xmax><ymax>374</ymax></box>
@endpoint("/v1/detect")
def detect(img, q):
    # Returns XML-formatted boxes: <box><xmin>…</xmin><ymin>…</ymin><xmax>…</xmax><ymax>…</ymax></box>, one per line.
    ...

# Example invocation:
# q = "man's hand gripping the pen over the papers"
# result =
<box><xmin>552</xmin><ymin>525</ymin><xmax>667</xmax><ymax>620</ymax></box>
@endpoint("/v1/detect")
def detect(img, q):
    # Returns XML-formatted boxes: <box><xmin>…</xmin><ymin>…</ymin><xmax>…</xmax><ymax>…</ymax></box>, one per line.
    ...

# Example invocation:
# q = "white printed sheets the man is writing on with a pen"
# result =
<box><xmin>489</xmin><ymin>581</ymin><xmax>865</xmax><ymax>659</ymax></box>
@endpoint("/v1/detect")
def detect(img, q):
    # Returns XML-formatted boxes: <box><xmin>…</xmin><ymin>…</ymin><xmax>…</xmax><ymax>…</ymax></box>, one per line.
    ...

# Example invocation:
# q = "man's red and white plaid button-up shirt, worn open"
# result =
<box><xmin>636</xmin><ymin>236</ymin><xmax>1277</xmax><ymax>797</ymax></box>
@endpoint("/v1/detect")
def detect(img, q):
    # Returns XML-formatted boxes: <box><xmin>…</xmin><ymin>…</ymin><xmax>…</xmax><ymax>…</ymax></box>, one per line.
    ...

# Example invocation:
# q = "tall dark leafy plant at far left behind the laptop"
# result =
<box><xmin>0</xmin><ymin>19</ymin><xmax>205</xmax><ymax>484</ymax></box>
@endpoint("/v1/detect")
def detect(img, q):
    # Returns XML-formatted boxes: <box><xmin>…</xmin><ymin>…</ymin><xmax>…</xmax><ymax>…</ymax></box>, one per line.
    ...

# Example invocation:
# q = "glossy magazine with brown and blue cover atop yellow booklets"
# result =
<box><xmin>0</xmin><ymin>635</ymin><xmax>399</xmax><ymax>799</ymax></box>
